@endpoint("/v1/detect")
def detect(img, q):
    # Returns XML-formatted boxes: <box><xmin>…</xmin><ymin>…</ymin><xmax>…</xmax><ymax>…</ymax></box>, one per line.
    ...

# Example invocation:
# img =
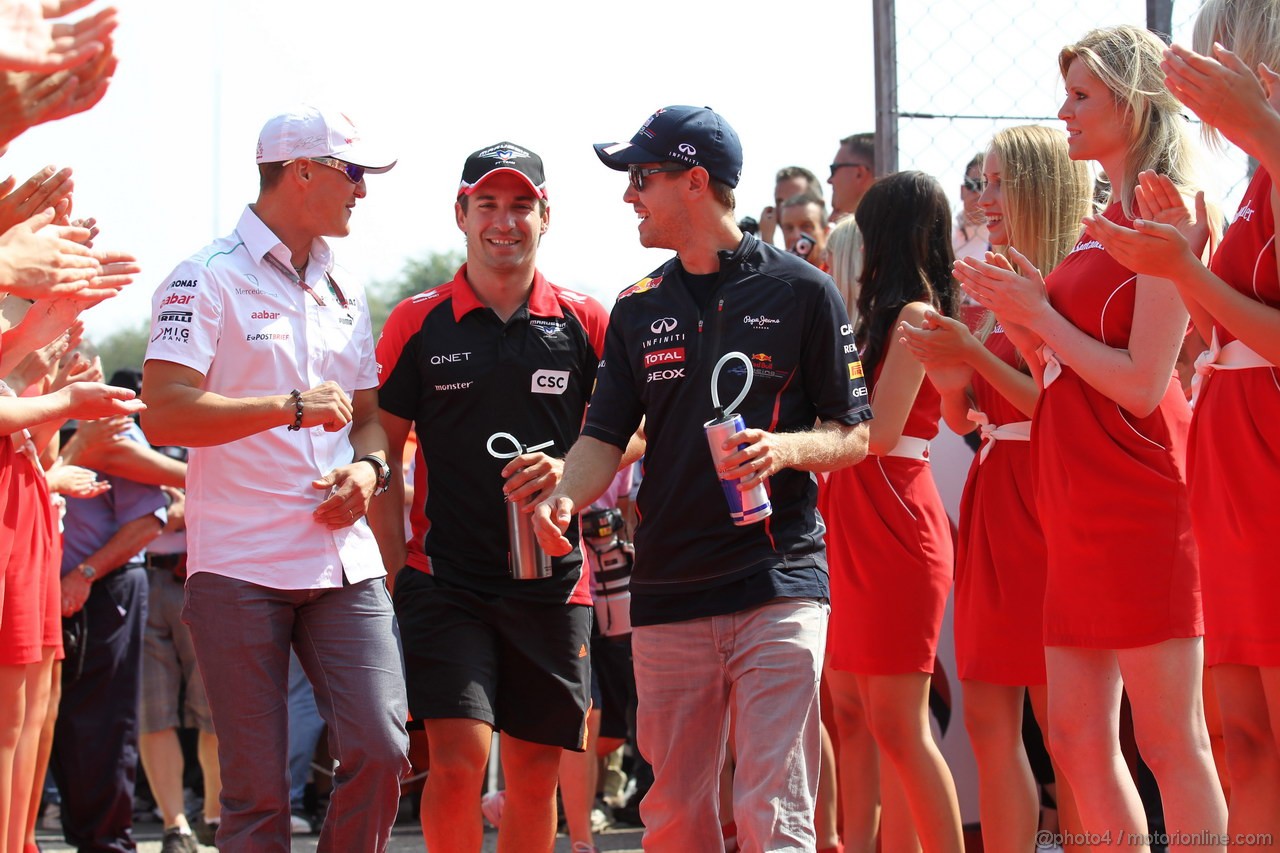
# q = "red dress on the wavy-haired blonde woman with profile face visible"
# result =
<box><xmin>1032</xmin><ymin>204</ymin><xmax>1203</xmax><ymax>649</ymax></box>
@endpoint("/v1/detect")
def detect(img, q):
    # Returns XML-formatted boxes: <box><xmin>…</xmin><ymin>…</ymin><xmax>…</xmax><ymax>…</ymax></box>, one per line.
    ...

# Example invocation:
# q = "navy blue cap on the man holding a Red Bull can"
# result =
<box><xmin>595</xmin><ymin>106</ymin><xmax>742</xmax><ymax>187</ymax></box>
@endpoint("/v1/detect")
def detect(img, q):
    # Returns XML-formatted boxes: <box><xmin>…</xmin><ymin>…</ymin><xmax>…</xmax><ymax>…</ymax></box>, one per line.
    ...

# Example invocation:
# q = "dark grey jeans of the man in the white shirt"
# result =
<box><xmin>183</xmin><ymin>573</ymin><xmax>408</xmax><ymax>853</ymax></box>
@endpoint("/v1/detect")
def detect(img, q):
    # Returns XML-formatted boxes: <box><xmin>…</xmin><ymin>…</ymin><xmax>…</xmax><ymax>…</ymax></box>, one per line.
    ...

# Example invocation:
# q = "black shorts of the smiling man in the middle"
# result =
<box><xmin>394</xmin><ymin>567</ymin><xmax>591</xmax><ymax>752</ymax></box>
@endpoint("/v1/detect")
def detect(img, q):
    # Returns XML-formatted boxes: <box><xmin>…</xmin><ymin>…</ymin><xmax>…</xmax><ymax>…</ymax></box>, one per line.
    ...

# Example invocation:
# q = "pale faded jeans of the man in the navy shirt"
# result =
<box><xmin>631</xmin><ymin>598</ymin><xmax>829</xmax><ymax>853</ymax></box>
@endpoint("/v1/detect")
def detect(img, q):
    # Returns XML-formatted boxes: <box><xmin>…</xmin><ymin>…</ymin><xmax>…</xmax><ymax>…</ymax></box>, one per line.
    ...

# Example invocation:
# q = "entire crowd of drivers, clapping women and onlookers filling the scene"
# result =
<box><xmin>0</xmin><ymin>0</ymin><xmax>1280</xmax><ymax>853</ymax></box>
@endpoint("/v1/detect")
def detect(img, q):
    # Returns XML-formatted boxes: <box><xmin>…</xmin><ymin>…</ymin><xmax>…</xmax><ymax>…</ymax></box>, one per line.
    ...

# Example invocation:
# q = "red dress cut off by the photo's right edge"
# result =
<box><xmin>1188</xmin><ymin>169</ymin><xmax>1280</xmax><ymax>666</ymax></box>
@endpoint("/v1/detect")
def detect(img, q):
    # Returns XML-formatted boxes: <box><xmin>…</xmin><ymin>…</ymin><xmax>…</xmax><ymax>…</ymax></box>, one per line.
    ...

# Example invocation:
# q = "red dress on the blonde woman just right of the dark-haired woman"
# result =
<box><xmin>955</xmin><ymin>325</ymin><xmax>1046</xmax><ymax>686</ymax></box>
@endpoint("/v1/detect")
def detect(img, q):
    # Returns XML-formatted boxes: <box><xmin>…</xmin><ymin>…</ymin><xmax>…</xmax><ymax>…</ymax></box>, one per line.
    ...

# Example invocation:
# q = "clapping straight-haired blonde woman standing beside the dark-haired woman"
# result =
<box><xmin>901</xmin><ymin>126</ymin><xmax>1091</xmax><ymax>853</ymax></box>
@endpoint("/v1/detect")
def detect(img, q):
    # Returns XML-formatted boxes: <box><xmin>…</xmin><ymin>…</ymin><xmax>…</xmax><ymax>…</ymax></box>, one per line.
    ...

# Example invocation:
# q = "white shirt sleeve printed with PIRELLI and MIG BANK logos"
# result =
<box><xmin>146</xmin><ymin>252</ymin><xmax>223</xmax><ymax>375</ymax></box>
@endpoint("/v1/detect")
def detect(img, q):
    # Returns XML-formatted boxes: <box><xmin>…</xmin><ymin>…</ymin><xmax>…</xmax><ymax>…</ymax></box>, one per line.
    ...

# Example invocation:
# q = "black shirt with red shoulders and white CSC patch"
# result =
<box><xmin>378</xmin><ymin>265</ymin><xmax>608</xmax><ymax>605</ymax></box>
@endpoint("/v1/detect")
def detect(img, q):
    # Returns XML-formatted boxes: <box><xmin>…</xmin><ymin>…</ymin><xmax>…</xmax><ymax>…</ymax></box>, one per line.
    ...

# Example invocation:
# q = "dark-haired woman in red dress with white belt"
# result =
<box><xmin>827</xmin><ymin>172</ymin><xmax>963</xmax><ymax>852</ymax></box>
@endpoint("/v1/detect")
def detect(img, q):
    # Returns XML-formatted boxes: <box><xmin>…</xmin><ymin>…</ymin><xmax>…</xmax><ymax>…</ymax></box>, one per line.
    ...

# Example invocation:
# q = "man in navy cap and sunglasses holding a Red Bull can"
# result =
<box><xmin>535</xmin><ymin>106</ymin><xmax>870</xmax><ymax>852</ymax></box>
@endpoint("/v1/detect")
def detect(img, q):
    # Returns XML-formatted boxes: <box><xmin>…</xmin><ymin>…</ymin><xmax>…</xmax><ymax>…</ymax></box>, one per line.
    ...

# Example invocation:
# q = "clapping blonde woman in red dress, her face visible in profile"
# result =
<box><xmin>956</xmin><ymin>26</ymin><xmax>1226</xmax><ymax>848</ymax></box>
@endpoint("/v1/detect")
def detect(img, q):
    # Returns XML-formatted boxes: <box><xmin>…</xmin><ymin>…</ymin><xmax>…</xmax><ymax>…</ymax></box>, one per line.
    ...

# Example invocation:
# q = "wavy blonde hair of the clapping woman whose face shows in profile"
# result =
<box><xmin>1057</xmin><ymin>24</ymin><xmax>1196</xmax><ymax>218</ymax></box>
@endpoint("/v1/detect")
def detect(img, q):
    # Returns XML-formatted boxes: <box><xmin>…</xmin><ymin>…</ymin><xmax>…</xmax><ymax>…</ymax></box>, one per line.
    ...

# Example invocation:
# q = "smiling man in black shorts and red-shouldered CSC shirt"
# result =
<box><xmin>374</xmin><ymin>142</ymin><xmax>608</xmax><ymax>853</ymax></box>
